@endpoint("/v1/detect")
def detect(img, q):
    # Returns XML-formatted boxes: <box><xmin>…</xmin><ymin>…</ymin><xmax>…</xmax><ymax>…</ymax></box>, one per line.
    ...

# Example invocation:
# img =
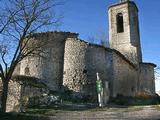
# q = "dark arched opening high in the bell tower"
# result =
<box><xmin>116</xmin><ymin>13</ymin><xmax>124</xmax><ymax>33</ymax></box>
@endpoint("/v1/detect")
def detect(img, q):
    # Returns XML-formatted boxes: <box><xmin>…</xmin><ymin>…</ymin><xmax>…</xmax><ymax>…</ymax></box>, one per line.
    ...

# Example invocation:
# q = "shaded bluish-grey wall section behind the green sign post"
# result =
<box><xmin>85</xmin><ymin>45</ymin><xmax>113</xmax><ymax>99</ymax></box>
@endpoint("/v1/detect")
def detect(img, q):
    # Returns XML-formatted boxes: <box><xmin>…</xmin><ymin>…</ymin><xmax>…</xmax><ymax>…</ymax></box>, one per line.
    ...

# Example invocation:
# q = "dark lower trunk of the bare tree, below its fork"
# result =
<box><xmin>1</xmin><ymin>80</ymin><xmax>9</xmax><ymax>112</ymax></box>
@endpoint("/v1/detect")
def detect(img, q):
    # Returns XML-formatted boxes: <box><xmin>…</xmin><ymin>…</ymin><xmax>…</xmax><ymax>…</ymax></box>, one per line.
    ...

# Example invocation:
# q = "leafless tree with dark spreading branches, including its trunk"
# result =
<box><xmin>0</xmin><ymin>0</ymin><xmax>62</xmax><ymax>112</ymax></box>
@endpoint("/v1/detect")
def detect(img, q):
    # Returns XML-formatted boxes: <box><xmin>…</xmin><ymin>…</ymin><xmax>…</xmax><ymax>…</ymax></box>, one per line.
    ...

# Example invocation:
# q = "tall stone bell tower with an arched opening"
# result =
<box><xmin>108</xmin><ymin>0</ymin><xmax>142</xmax><ymax>64</ymax></box>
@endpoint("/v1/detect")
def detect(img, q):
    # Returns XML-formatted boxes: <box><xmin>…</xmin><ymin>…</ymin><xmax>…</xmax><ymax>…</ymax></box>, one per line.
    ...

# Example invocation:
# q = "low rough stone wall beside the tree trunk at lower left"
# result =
<box><xmin>0</xmin><ymin>80</ymin><xmax>49</xmax><ymax>112</ymax></box>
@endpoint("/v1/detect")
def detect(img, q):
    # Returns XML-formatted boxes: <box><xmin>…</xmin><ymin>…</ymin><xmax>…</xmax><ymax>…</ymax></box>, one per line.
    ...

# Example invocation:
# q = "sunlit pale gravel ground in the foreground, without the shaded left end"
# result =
<box><xmin>49</xmin><ymin>106</ymin><xmax>160</xmax><ymax>120</ymax></box>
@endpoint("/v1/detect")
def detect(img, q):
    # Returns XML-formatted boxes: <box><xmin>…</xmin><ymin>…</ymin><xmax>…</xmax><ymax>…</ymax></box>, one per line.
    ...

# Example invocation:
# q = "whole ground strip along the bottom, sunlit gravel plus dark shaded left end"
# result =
<box><xmin>0</xmin><ymin>106</ymin><xmax>160</xmax><ymax>120</ymax></box>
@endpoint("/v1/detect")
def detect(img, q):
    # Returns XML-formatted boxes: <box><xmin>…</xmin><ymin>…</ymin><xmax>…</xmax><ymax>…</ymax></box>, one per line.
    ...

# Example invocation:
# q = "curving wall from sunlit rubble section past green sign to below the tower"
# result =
<box><xmin>63</xmin><ymin>39</ymin><xmax>138</xmax><ymax>100</ymax></box>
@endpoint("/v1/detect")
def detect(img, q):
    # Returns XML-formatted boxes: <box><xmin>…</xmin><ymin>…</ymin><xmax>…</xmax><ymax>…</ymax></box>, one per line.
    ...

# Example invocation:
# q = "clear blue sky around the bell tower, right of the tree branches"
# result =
<box><xmin>56</xmin><ymin>0</ymin><xmax>160</xmax><ymax>90</ymax></box>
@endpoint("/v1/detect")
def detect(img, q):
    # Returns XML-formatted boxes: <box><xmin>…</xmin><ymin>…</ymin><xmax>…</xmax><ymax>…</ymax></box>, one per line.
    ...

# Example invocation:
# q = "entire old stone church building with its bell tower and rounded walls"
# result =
<box><xmin>12</xmin><ymin>0</ymin><xmax>156</xmax><ymax>103</ymax></box>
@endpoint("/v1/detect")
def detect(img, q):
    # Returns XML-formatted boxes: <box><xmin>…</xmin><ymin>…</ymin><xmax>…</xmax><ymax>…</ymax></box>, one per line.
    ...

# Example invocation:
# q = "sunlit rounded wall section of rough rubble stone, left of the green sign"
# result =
<box><xmin>63</xmin><ymin>38</ymin><xmax>88</xmax><ymax>92</ymax></box>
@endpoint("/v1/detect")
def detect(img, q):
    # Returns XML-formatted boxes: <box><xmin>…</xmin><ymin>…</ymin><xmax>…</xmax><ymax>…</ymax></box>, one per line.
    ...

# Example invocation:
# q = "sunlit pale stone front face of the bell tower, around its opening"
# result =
<box><xmin>108</xmin><ymin>4</ymin><xmax>130</xmax><ymax>48</ymax></box>
